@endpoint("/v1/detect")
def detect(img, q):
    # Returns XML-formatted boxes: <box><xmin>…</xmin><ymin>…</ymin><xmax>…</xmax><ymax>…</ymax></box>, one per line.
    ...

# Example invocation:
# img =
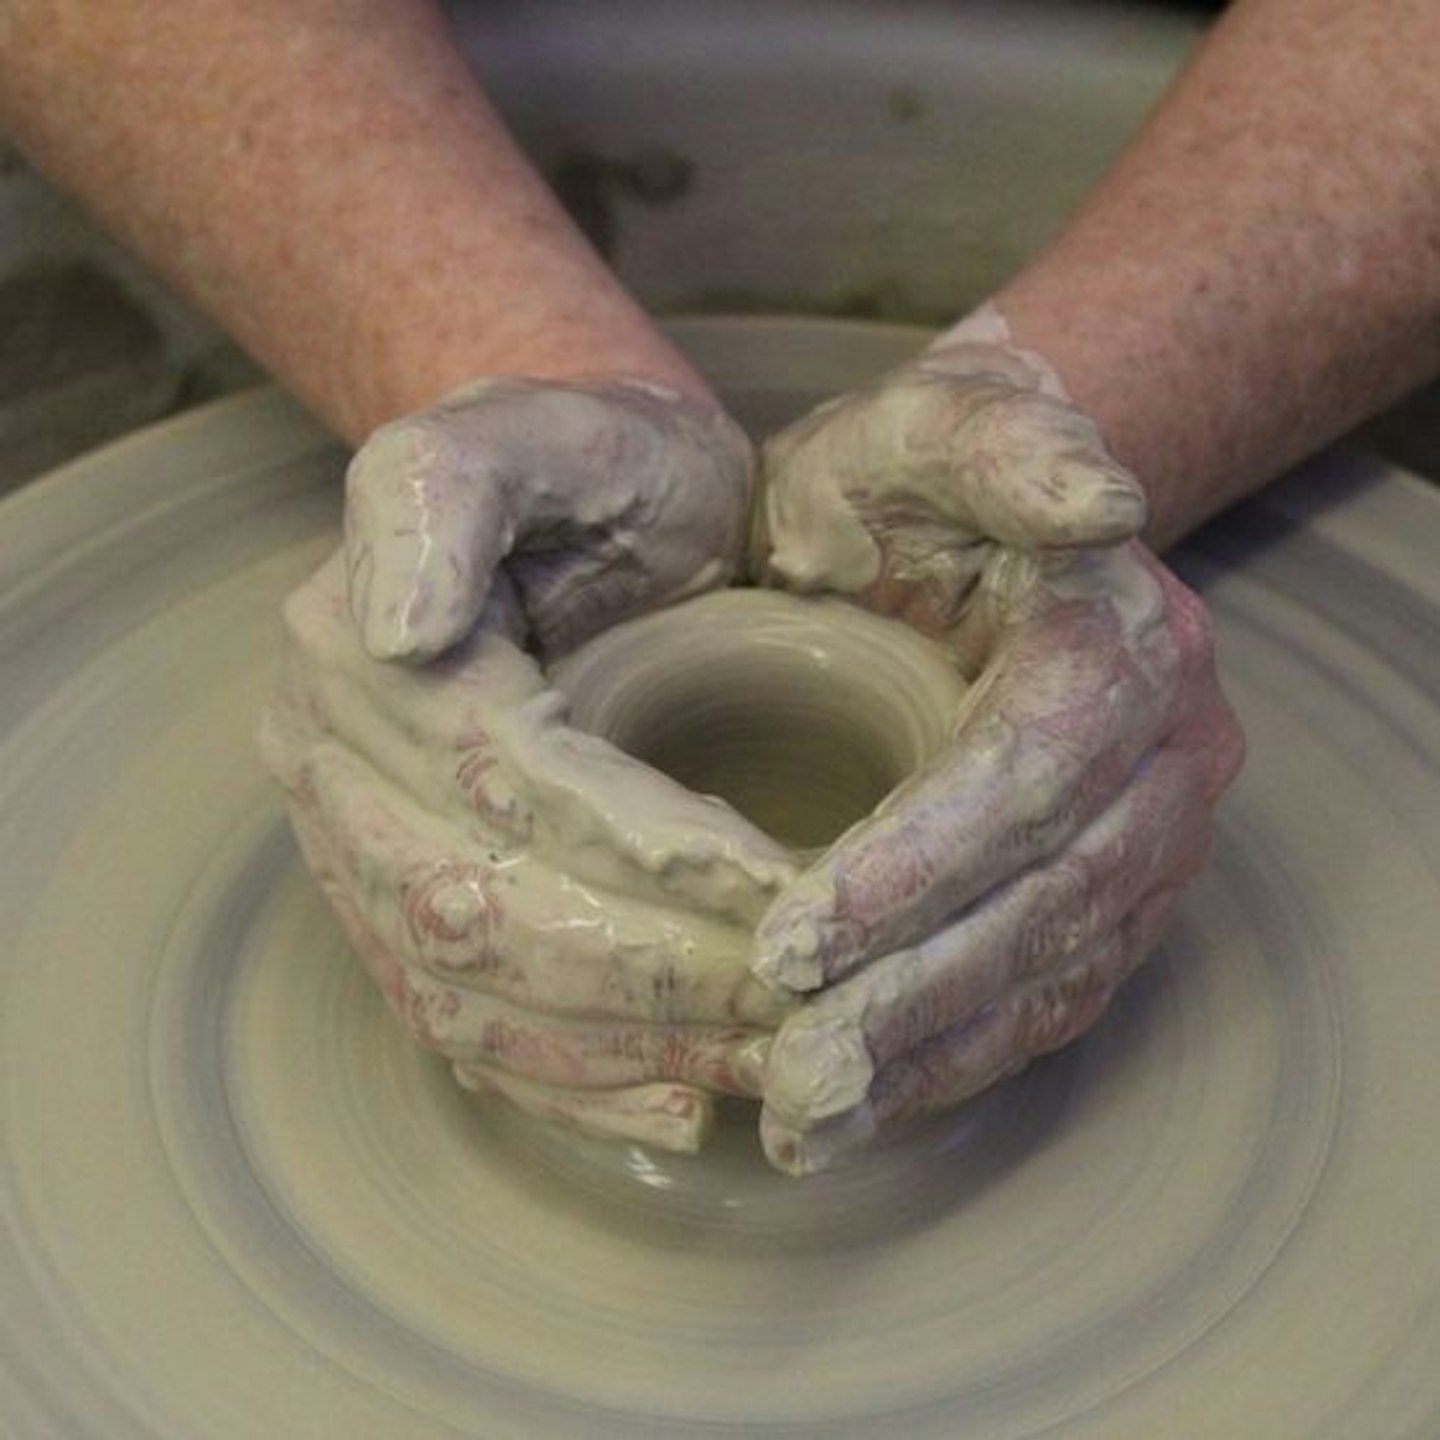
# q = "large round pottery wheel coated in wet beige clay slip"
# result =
<box><xmin>0</xmin><ymin>323</ymin><xmax>1440</xmax><ymax>1440</ymax></box>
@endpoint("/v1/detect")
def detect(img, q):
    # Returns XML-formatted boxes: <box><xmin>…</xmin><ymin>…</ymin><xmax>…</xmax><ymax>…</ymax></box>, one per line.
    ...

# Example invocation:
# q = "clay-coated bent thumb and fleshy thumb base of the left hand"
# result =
<box><xmin>346</xmin><ymin>379</ymin><xmax>753</xmax><ymax>660</ymax></box>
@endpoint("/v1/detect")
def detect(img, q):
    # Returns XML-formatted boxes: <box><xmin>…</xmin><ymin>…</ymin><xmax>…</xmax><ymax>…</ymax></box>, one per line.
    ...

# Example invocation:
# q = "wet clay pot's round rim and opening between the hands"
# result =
<box><xmin>553</xmin><ymin>589</ymin><xmax>965</xmax><ymax>860</ymax></box>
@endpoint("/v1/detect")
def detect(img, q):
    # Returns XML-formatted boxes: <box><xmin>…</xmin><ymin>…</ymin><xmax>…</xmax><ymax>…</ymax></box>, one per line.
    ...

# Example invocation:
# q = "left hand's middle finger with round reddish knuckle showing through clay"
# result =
<box><xmin>291</xmin><ymin>744</ymin><xmax>788</xmax><ymax>1025</ymax></box>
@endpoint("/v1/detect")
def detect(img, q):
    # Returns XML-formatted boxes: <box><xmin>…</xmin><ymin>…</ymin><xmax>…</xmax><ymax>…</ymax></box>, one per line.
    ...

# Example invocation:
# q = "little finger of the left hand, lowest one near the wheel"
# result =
<box><xmin>455</xmin><ymin>1066</ymin><xmax>714</xmax><ymax>1155</ymax></box>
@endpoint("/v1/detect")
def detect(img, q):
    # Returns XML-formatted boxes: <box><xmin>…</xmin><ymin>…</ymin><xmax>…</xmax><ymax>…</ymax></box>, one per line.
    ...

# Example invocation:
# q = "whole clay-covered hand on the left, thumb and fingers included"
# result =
<box><xmin>262</xmin><ymin>383</ymin><xmax>793</xmax><ymax>1149</ymax></box>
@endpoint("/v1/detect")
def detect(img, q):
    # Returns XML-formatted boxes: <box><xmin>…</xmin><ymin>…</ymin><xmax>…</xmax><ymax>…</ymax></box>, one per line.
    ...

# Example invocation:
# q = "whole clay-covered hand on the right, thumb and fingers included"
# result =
<box><xmin>756</xmin><ymin>315</ymin><xmax>1243</xmax><ymax>1172</ymax></box>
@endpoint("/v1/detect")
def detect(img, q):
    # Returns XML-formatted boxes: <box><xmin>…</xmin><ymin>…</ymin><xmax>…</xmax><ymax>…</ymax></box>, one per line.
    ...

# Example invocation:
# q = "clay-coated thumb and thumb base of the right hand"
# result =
<box><xmin>752</xmin><ymin>367</ymin><xmax>1145</xmax><ymax>593</ymax></box>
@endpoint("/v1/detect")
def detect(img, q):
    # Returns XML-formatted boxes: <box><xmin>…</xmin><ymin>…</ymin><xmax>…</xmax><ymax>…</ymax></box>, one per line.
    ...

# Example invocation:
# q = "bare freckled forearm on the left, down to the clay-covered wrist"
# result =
<box><xmin>0</xmin><ymin>0</ymin><xmax>704</xmax><ymax>441</ymax></box>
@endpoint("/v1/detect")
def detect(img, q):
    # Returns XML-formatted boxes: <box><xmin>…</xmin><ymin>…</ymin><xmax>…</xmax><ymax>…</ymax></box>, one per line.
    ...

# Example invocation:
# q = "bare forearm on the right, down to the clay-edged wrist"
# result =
<box><xmin>998</xmin><ymin>0</ymin><xmax>1440</xmax><ymax>544</ymax></box>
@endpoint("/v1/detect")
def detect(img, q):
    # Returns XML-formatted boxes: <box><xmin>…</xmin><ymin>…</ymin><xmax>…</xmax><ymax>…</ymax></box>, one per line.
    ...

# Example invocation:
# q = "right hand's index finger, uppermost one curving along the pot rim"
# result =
<box><xmin>753</xmin><ymin>553</ymin><xmax>1178</xmax><ymax>991</ymax></box>
